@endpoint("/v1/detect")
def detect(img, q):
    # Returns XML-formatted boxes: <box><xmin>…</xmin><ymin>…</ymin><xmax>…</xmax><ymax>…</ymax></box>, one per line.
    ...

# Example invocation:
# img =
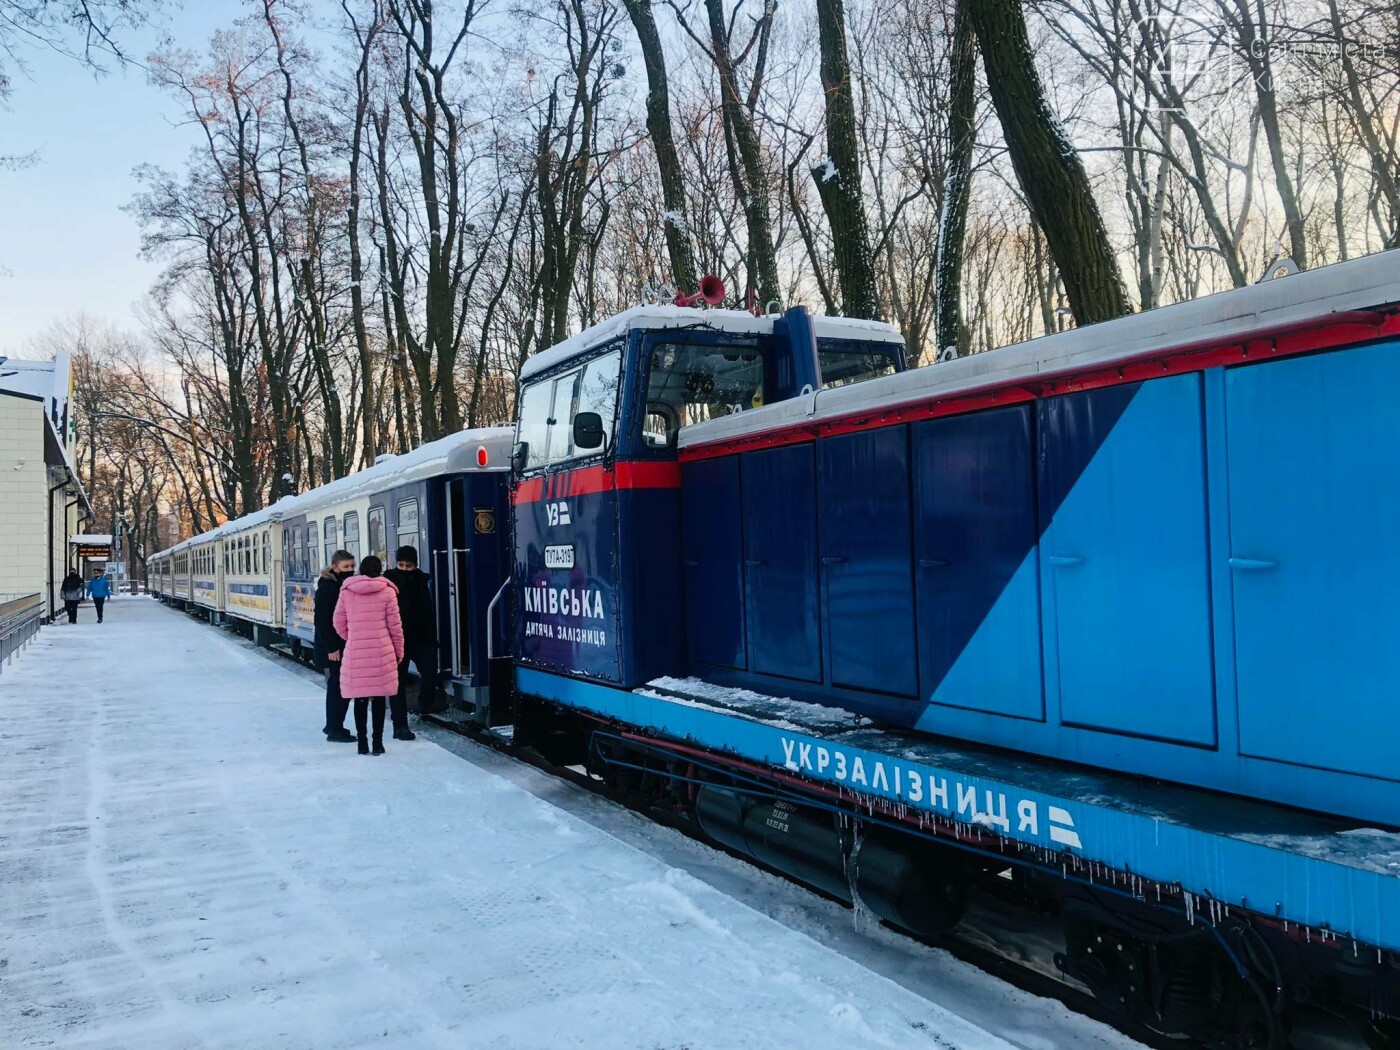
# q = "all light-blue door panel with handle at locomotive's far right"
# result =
<box><xmin>1225</xmin><ymin>343</ymin><xmax>1400</xmax><ymax>784</ymax></box>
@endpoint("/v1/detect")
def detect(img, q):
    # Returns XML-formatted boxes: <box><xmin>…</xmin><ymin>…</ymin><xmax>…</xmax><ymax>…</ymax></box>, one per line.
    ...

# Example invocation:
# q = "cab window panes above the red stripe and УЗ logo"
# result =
<box><xmin>517</xmin><ymin>347</ymin><xmax>622</xmax><ymax>470</ymax></box>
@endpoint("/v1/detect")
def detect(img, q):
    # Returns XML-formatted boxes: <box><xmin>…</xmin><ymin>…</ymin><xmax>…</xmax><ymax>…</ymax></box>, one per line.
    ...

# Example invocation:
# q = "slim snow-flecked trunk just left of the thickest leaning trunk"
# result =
<box><xmin>934</xmin><ymin>0</ymin><xmax>977</xmax><ymax>360</ymax></box>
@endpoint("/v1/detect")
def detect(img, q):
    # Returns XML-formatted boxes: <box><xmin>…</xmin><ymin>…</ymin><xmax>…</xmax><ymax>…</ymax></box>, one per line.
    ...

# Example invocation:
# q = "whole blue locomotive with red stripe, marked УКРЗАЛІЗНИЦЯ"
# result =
<box><xmin>512</xmin><ymin>253</ymin><xmax>1400</xmax><ymax>1046</ymax></box>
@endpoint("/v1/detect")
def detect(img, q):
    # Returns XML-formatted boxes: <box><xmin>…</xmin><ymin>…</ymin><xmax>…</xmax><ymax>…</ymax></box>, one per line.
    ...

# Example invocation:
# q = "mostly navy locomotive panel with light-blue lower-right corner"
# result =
<box><xmin>913</xmin><ymin>405</ymin><xmax>1044</xmax><ymax>729</ymax></box>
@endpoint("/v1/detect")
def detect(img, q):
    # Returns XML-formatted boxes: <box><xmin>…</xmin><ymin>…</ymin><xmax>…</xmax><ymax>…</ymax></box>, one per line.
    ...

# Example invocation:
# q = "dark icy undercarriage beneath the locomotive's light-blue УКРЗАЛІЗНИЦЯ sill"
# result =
<box><xmin>514</xmin><ymin>697</ymin><xmax>1400</xmax><ymax>1050</ymax></box>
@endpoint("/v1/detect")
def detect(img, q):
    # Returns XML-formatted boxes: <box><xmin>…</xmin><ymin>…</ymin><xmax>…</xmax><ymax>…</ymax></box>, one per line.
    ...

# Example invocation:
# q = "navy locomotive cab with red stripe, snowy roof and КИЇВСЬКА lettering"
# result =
<box><xmin>514</xmin><ymin>307</ymin><xmax>904</xmax><ymax>687</ymax></box>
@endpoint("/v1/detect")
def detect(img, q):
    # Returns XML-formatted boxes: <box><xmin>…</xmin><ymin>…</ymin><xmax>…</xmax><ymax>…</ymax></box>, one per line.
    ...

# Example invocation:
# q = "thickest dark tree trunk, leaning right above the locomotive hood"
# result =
<box><xmin>965</xmin><ymin>0</ymin><xmax>1130</xmax><ymax>325</ymax></box>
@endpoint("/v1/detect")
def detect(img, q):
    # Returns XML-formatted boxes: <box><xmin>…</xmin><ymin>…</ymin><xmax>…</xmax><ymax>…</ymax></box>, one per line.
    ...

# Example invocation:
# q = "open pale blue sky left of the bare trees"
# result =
<box><xmin>0</xmin><ymin>0</ymin><xmax>248</xmax><ymax>357</ymax></box>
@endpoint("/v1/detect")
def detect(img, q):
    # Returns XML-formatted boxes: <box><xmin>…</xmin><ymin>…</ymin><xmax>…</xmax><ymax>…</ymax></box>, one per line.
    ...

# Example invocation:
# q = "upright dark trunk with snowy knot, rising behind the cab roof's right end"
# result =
<box><xmin>812</xmin><ymin>0</ymin><xmax>881</xmax><ymax>319</ymax></box>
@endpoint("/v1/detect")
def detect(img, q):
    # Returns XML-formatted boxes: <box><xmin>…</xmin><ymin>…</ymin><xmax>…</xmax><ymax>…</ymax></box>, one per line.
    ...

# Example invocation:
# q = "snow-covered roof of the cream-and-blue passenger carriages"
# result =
<box><xmin>164</xmin><ymin>427</ymin><xmax>515</xmax><ymax>554</ymax></box>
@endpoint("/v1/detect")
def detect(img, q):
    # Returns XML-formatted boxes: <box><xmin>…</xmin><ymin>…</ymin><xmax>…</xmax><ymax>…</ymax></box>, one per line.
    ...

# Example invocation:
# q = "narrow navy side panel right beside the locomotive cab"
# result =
<box><xmin>680</xmin><ymin>456</ymin><xmax>749</xmax><ymax>671</ymax></box>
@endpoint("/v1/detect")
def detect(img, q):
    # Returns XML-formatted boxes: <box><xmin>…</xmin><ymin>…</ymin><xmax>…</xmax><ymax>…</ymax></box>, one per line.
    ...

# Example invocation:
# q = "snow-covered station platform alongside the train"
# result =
<box><xmin>0</xmin><ymin>599</ymin><xmax>1130</xmax><ymax>1050</ymax></box>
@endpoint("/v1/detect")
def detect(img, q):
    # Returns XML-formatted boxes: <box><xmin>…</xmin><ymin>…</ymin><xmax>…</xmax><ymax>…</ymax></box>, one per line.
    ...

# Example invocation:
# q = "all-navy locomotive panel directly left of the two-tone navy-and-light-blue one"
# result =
<box><xmin>818</xmin><ymin>427</ymin><xmax>918</xmax><ymax>697</ymax></box>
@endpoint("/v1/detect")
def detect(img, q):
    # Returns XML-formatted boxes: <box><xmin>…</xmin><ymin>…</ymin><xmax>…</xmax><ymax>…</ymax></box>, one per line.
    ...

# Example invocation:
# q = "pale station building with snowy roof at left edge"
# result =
<box><xmin>0</xmin><ymin>354</ymin><xmax>92</xmax><ymax>620</ymax></box>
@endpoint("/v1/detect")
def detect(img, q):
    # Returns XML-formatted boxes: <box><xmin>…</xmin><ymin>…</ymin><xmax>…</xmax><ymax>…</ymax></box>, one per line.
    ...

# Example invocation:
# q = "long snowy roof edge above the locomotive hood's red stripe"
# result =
<box><xmin>679</xmin><ymin>251</ymin><xmax>1400</xmax><ymax>448</ymax></box>
